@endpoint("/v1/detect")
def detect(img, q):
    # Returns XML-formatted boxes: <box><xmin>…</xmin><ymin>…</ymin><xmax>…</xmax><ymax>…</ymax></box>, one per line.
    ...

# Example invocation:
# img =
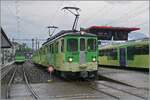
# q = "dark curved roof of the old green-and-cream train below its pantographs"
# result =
<box><xmin>42</xmin><ymin>30</ymin><xmax>96</xmax><ymax>45</ymax></box>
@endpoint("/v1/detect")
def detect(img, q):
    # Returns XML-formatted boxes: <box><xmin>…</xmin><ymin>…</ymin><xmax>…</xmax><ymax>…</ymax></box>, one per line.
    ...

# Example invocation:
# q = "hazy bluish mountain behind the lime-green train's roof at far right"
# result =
<box><xmin>128</xmin><ymin>32</ymin><xmax>148</xmax><ymax>40</ymax></box>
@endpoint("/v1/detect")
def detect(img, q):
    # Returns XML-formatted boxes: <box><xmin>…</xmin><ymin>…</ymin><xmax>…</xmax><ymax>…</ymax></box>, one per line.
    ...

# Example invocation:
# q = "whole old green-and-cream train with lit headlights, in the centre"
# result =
<box><xmin>32</xmin><ymin>31</ymin><xmax>98</xmax><ymax>78</ymax></box>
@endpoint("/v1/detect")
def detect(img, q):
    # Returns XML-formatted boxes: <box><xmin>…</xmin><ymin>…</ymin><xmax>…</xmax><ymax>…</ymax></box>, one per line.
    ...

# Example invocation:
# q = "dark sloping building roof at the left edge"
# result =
<box><xmin>1</xmin><ymin>27</ymin><xmax>12</xmax><ymax>48</ymax></box>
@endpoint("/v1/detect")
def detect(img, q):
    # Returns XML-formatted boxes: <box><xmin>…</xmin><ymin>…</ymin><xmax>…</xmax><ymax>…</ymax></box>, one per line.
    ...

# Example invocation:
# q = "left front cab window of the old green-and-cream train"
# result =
<box><xmin>67</xmin><ymin>39</ymin><xmax>78</xmax><ymax>52</ymax></box>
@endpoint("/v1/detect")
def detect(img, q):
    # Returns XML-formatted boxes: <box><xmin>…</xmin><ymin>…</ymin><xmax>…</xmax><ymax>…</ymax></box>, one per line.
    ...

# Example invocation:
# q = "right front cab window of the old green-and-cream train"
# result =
<box><xmin>87</xmin><ymin>39</ymin><xmax>96</xmax><ymax>51</ymax></box>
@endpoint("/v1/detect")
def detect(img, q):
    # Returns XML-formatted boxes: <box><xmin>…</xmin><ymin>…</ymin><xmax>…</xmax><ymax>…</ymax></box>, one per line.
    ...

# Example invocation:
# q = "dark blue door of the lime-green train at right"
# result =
<box><xmin>119</xmin><ymin>48</ymin><xmax>126</xmax><ymax>66</ymax></box>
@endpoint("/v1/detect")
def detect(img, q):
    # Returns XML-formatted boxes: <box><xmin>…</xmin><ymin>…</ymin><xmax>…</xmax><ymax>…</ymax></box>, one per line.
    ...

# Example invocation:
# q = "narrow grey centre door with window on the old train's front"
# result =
<box><xmin>80</xmin><ymin>38</ymin><xmax>85</xmax><ymax>64</ymax></box>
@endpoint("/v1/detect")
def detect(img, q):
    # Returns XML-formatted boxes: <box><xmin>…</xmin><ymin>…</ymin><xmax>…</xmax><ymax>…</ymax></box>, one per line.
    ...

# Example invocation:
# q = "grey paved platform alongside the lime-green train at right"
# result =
<box><xmin>98</xmin><ymin>67</ymin><xmax>149</xmax><ymax>89</ymax></box>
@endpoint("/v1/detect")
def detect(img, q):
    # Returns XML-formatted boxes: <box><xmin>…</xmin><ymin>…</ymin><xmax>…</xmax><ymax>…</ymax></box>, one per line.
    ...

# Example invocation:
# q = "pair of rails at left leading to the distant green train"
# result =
<box><xmin>6</xmin><ymin>65</ymin><xmax>39</xmax><ymax>100</ymax></box>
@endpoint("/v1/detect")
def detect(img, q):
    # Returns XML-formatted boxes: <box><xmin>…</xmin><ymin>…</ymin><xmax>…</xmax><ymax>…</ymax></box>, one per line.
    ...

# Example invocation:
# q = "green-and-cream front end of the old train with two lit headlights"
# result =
<box><xmin>59</xmin><ymin>33</ymin><xmax>98</xmax><ymax>78</ymax></box>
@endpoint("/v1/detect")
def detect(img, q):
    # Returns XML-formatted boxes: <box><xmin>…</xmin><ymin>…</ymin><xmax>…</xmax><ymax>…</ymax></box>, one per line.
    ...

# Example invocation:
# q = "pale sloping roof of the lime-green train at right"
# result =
<box><xmin>99</xmin><ymin>39</ymin><xmax>150</xmax><ymax>50</ymax></box>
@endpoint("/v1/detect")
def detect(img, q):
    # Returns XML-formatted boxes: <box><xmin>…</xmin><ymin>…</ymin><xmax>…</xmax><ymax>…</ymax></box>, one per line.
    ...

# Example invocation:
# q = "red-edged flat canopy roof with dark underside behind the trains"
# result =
<box><xmin>84</xmin><ymin>26</ymin><xmax>140</xmax><ymax>40</ymax></box>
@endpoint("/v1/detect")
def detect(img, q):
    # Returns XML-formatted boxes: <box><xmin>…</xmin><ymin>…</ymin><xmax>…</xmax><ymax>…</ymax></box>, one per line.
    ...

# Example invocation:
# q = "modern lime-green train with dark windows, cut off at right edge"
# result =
<box><xmin>98</xmin><ymin>39</ymin><xmax>149</xmax><ymax>69</ymax></box>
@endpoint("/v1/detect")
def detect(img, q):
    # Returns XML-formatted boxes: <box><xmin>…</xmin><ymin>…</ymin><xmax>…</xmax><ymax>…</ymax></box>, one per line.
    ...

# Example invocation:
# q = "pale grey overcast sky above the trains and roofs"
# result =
<box><xmin>1</xmin><ymin>1</ymin><xmax>149</xmax><ymax>47</ymax></box>
